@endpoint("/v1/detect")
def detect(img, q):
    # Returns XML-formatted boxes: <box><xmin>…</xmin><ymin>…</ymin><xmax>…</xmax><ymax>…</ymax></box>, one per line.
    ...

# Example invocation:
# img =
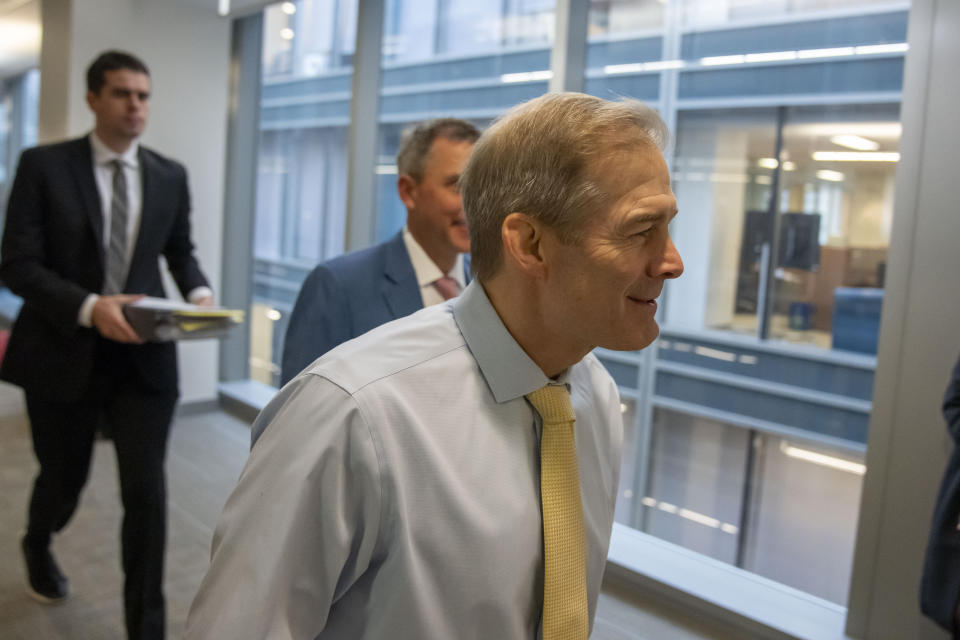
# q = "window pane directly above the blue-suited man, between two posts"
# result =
<box><xmin>376</xmin><ymin>0</ymin><xmax>555</xmax><ymax>241</ymax></box>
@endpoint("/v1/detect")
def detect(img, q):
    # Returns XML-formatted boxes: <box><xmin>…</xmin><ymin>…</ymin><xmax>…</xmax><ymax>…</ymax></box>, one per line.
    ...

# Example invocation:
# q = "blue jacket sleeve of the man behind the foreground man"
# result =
<box><xmin>280</xmin><ymin>264</ymin><xmax>353</xmax><ymax>386</ymax></box>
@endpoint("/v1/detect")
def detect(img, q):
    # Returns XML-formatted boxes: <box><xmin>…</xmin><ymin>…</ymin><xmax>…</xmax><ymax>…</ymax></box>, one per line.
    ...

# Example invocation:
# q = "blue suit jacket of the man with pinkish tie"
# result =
<box><xmin>280</xmin><ymin>232</ymin><xmax>470</xmax><ymax>385</ymax></box>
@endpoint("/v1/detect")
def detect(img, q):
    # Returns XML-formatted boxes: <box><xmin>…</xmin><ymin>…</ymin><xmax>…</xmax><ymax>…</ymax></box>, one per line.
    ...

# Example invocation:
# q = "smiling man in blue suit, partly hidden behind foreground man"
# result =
<box><xmin>280</xmin><ymin>118</ymin><xmax>480</xmax><ymax>385</ymax></box>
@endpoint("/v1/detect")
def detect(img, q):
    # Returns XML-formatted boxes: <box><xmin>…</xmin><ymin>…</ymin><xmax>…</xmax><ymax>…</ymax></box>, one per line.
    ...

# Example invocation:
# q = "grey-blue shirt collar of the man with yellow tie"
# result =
<box><xmin>451</xmin><ymin>279</ymin><xmax>569</xmax><ymax>403</ymax></box>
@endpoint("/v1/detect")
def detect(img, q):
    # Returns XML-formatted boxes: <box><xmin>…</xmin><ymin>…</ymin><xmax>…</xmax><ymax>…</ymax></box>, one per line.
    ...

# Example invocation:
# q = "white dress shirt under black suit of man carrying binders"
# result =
<box><xmin>77</xmin><ymin>132</ymin><xmax>213</xmax><ymax>327</ymax></box>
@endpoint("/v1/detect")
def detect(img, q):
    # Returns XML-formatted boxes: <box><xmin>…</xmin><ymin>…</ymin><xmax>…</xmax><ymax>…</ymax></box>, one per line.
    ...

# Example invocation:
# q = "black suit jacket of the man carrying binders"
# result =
<box><xmin>0</xmin><ymin>137</ymin><xmax>208</xmax><ymax>401</ymax></box>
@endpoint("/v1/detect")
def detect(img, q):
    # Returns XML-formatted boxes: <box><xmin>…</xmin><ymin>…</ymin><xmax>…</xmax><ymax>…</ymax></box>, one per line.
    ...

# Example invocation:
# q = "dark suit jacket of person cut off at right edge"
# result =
<box><xmin>920</xmin><ymin>360</ymin><xmax>960</xmax><ymax>638</ymax></box>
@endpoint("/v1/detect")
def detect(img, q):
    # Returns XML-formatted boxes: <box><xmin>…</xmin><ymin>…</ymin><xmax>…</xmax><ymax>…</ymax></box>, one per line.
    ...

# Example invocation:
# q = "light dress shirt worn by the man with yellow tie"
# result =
<box><xmin>186</xmin><ymin>281</ymin><xmax>623</xmax><ymax>640</ymax></box>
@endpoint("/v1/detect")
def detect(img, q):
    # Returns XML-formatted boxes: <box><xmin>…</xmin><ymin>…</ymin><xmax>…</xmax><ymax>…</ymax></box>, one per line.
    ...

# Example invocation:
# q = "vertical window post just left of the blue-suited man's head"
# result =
<box><xmin>345</xmin><ymin>0</ymin><xmax>384</xmax><ymax>251</ymax></box>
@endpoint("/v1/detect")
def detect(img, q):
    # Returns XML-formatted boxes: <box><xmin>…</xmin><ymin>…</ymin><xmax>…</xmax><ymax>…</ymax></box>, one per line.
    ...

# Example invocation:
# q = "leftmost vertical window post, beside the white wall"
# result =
<box><xmin>220</xmin><ymin>13</ymin><xmax>263</xmax><ymax>381</ymax></box>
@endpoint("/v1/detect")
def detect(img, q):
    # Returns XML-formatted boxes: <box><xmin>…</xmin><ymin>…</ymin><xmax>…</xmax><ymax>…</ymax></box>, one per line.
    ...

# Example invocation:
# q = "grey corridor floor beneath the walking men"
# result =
<box><xmin>0</xmin><ymin>383</ymin><xmax>734</xmax><ymax>640</ymax></box>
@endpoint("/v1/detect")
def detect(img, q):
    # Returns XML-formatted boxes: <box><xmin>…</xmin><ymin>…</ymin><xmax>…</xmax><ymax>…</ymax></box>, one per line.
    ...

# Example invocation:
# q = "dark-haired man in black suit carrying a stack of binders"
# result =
<box><xmin>0</xmin><ymin>51</ymin><xmax>212</xmax><ymax>638</ymax></box>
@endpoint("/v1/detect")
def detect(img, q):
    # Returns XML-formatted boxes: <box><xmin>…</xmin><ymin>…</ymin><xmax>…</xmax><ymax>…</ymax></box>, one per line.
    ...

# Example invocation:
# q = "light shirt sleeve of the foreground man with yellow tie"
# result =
<box><xmin>185</xmin><ymin>375</ymin><xmax>383</xmax><ymax>640</ymax></box>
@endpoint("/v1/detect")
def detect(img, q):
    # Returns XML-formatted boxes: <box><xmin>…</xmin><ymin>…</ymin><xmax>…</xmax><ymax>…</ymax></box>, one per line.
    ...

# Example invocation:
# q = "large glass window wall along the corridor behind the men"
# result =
<box><xmin>244</xmin><ymin>0</ymin><xmax>909</xmax><ymax>604</ymax></box>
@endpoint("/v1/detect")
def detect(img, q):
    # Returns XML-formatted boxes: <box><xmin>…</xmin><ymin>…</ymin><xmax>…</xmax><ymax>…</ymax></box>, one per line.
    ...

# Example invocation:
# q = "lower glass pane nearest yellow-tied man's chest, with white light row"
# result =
<box><xmin>640</xmin><ymin>409</ymin><xmax>749</xmax><ymax>563</ymax></box>
